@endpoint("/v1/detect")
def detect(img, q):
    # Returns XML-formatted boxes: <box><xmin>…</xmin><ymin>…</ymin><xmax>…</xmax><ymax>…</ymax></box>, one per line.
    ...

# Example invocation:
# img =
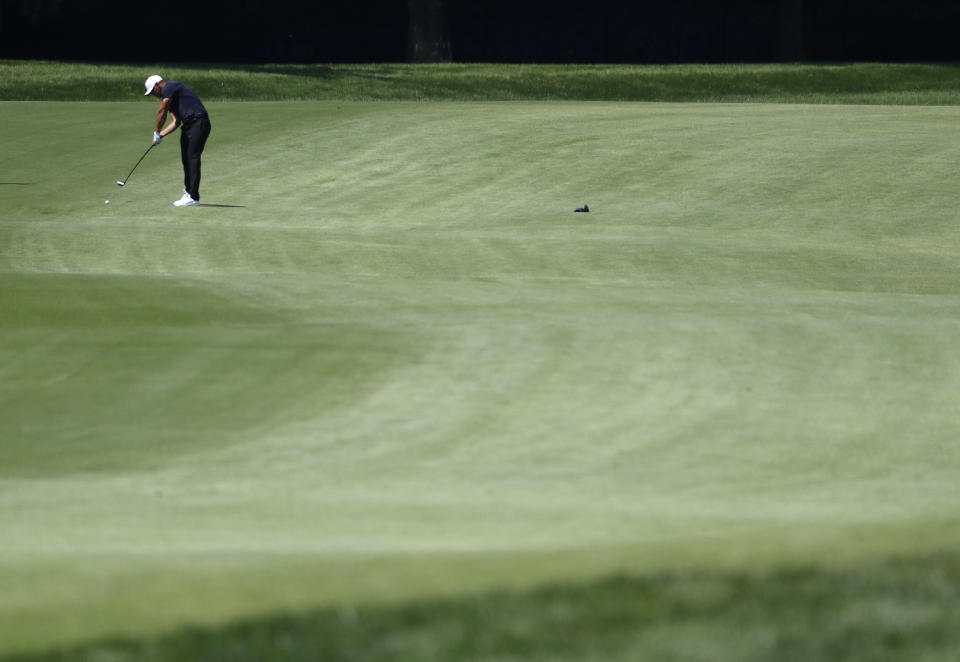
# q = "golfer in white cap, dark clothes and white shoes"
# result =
<box><xmin>143</xmin><ymin>75</ymin><xmax>210</xmax><ymax>207</ymax></box>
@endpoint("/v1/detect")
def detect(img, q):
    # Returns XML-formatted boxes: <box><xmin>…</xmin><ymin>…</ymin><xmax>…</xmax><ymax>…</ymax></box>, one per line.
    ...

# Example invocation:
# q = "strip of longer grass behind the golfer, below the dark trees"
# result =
<box><xmin>0</xmin><ymin>60</ymin><xmax>960</xmax><ymax>105</ymax></box>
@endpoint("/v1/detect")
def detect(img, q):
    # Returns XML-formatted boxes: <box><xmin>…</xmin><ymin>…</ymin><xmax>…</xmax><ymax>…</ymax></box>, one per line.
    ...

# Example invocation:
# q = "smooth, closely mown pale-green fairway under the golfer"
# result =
<box><xmin>0</xmin><ymin>96</ymin><xmax>960</xmax><ymax>660</ymax></box>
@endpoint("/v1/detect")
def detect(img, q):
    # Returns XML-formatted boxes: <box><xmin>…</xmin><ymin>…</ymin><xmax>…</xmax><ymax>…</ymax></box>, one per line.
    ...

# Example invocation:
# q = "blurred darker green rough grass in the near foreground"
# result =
<box><xmin>11</xmin><ymin>557</ymin><xmax>960</xmax><ymax>662</ymax></box>
